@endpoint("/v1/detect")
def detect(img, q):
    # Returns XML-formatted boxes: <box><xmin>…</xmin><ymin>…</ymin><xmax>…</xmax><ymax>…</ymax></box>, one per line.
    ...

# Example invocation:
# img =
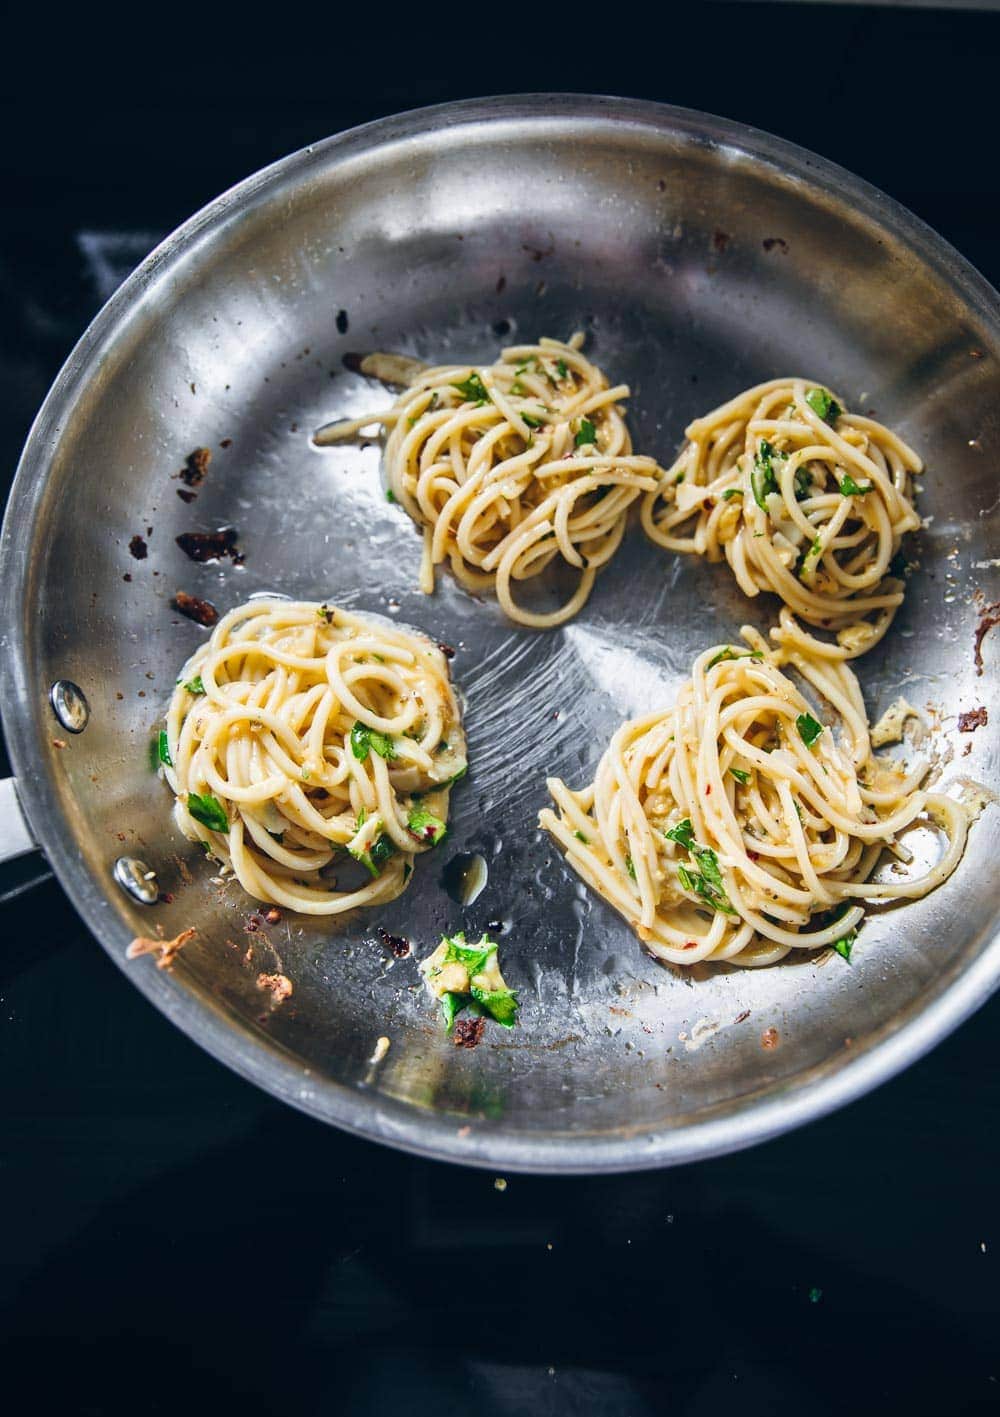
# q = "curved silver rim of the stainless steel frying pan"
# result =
<box><xmin>0</xmin><ymin>94</ymin><xmax>1000</xmax><ymax>1175</ymax></box>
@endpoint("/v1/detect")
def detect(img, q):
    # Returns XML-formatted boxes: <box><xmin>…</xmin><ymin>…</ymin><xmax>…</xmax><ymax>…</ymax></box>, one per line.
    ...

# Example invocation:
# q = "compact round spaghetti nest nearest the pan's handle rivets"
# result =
<box><xmin>160</xmin><ymin>599</ymin><xmax>466</xmax><ymax>915</ymax></box>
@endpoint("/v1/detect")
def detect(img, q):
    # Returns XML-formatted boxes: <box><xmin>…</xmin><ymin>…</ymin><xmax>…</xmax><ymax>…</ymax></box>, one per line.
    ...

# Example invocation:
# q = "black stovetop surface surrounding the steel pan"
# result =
<box><xmin>0</xmin><ymin>3</ymin><xmax>1000</xmax><ymax>1417</ymax></box>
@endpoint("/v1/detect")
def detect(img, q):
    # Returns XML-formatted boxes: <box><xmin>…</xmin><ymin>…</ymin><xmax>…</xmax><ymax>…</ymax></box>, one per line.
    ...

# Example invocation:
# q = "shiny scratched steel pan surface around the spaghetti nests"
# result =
<box><xmin>3</xmin><ymin>96</ymin><xmax>1000</xmax><ymax>1172</ymax></box>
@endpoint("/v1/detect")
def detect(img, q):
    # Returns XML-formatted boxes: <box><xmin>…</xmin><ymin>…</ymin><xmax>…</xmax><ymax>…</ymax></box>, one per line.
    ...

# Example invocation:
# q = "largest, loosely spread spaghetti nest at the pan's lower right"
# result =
<box><xmin>538</xmin><ymin>628</ymin><xmax>967</xmax><ymax>965</ymax></box>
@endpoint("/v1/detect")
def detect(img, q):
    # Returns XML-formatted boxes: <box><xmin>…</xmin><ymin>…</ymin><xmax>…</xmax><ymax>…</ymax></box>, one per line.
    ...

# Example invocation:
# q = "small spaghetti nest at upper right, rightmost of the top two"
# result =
<box><xmin>642</xmin><ymin>378</ymin><xmax>922</xmax><ymax>659</ymax></box>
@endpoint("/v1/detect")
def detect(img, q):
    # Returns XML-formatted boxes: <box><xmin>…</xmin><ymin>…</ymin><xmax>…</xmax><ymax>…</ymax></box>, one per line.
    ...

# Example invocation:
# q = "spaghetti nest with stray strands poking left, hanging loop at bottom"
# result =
<box><xmin>316</xmin><ymin>334</ymin><xmax>660</xmax><ymax>628</ymax></box>
